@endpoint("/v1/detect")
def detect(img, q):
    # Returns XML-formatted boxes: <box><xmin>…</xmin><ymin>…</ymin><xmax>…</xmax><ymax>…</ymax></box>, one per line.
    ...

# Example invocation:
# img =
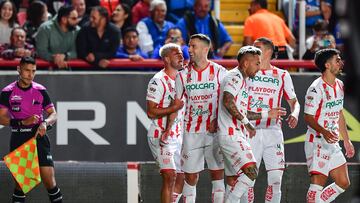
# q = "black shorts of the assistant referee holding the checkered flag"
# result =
<box><xmin>10</xmin><ymin>126</ymin><xmax>54</xmax><ymax>167</ymax></box>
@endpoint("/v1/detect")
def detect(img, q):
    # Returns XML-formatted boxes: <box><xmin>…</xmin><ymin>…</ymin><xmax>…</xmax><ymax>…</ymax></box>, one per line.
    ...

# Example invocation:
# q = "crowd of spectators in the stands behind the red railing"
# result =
<box><xmin>0</xmin><ymin>0</ymin><xmax>342</xmax><ymax>68</ymax></box>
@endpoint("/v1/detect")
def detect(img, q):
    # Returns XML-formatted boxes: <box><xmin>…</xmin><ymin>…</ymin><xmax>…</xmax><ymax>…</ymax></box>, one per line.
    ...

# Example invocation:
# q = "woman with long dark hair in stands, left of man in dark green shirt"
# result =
<box><xmin>23</xmin><ymin>1</ymin><xmax>49</xmax><ymax>44</ymax></box>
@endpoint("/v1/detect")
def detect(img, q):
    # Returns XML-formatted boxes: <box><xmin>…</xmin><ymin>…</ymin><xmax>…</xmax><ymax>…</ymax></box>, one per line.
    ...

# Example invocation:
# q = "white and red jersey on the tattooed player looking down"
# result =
<box><xmin>218</xmin><ymin>67</ymin><xmax>248</xmax><ymax>136</ymax></box>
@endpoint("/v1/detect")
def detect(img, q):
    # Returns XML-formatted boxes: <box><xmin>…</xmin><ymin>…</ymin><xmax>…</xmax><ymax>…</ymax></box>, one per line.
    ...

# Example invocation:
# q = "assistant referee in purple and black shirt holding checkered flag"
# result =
<box><xmin>0</xmin><ymin>57</ymin><xmax>62</xmax><ymax>202</ymax></box>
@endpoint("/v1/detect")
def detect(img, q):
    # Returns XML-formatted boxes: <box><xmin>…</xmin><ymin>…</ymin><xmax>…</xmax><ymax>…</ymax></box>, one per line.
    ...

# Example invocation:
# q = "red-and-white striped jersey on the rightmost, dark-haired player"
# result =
<box><xmin>304</xmin><ymin>77</ymin><xmax>344</xmax><ymax>142</ymax></box>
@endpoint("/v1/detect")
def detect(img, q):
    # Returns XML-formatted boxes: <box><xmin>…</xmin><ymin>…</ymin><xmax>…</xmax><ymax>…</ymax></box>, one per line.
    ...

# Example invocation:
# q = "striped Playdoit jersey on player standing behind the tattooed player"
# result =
<box><xmin>247</xmin><ymin>66</ymin><xmax>296</xmax><ymax>129</ymax></box>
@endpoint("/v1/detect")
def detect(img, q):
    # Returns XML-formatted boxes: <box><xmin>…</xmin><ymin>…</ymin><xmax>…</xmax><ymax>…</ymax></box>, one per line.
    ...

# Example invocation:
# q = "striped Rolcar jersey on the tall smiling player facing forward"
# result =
<box><xmin>175</xmin><ymin>62</ymin><xmax>227</xmax><ymax>133</ymax></box>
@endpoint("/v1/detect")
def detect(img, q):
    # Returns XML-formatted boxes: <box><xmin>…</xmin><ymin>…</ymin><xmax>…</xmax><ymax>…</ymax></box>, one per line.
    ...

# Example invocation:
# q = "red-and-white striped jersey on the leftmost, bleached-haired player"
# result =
<box><xmin>146</xmin><ymin>69</ymin><xmax>183</xmax><ymax>138</ymax></box>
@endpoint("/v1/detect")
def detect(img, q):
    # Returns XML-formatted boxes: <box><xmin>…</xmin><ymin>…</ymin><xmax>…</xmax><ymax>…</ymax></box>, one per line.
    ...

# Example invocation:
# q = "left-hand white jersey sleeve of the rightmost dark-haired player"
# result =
<box><xmin>304</xmin><ymin>86</ymin><xmax>322</xmax><ymax>115</ymax></box>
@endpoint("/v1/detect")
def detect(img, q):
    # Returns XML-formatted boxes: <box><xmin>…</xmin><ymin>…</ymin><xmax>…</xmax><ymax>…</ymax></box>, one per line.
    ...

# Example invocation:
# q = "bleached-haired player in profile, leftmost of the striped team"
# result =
<box><xmin>146</xmin><ymin>43</ymin><xmax>184</xmax><ymax>203</ymax></box>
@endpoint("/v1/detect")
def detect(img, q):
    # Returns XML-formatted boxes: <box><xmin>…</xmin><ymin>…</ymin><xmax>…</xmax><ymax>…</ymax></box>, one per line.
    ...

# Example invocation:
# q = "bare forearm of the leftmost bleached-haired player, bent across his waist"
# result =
<box><xmin>146</xmin><ymin>101</ymin><xmax>183</xmax><ymax>119</ymax></box>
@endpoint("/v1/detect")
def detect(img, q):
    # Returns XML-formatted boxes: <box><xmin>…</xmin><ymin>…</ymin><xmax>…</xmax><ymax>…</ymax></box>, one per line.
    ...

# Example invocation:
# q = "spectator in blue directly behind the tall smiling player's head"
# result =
<box><xmin>177</xmin><ymin>0</ymin><xmax>232</xmax><ymax>58</ymax></box>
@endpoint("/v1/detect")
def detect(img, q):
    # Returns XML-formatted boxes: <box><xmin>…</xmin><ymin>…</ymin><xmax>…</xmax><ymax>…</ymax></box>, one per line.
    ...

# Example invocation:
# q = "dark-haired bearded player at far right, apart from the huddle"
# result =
<box><xmin>304</xmin><ymin>49</ymin><xmax>355</xmax><ymax>203</ymax></box>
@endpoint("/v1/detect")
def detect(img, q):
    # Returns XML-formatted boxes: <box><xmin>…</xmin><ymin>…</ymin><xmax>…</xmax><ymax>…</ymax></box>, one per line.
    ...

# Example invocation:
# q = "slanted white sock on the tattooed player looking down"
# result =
<box><xmin>225</xmin><ymin>173</ymin><xmax>255</xmax><ymax>203</ymax></box>
